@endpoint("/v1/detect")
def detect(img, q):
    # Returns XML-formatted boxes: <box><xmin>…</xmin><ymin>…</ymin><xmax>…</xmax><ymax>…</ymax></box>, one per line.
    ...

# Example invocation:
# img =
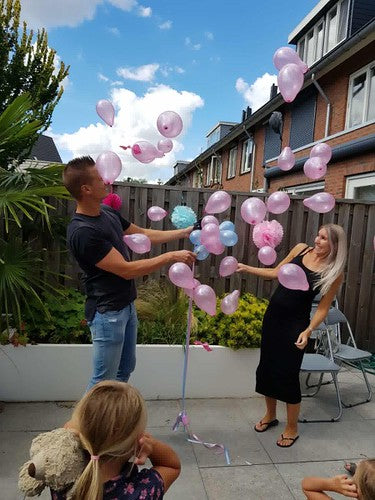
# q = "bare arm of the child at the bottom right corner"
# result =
<box><xmin>302</xmin><ymin>474</ymin><xmax>358</xmax><ymax>500</ymax></box>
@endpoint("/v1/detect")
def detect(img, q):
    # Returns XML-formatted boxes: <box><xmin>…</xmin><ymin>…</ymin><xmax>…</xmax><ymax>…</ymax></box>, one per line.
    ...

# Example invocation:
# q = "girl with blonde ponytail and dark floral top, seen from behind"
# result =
<box><xmin>52</xmin><ymin>380</ymin><xmax>181</xmax><ymax>500</ymax></box>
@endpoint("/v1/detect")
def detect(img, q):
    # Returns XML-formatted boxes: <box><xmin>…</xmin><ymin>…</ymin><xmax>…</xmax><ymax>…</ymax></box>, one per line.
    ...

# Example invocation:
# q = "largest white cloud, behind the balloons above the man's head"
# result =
<box><xmin>51</xmin><ymin>85</ymin><xmax>204</xmax><ymax>181</ymax></box>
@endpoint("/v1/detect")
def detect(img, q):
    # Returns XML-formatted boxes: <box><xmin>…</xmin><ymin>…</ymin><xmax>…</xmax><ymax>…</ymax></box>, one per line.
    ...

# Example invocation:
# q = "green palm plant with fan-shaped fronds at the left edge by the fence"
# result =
<box><xmin>0</xmin><ymin>93</ymin><xmax>69</xmax><ymax>331</ymax></box>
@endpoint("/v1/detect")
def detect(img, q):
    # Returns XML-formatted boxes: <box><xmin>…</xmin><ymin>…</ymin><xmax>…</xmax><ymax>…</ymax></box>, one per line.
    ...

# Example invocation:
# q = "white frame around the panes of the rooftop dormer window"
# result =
<box><xmin>297</xmin><ymin>0</ymin><xmax>350</xmax><ymax>66</ymax></box>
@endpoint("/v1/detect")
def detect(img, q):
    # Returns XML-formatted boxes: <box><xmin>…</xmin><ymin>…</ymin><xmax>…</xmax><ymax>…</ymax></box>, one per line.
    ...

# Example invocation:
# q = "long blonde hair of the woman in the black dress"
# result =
<box><xmin>315</xmin><ymin>224</ymin><xmax>347</xmax><ymax>295</ymax></box>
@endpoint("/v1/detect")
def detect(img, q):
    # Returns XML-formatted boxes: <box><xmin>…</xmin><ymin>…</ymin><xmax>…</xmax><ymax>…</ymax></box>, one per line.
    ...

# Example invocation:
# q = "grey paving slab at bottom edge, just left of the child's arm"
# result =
<box><xmin>201</xmin><ymin>464</ymin><xmax>294</xmax><ymax>500</ymax></box>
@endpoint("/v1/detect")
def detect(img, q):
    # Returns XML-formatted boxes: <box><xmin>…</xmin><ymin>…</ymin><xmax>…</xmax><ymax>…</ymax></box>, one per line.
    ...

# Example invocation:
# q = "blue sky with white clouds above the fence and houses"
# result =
<box><xmin>21</xmin><ymin>0</ymin><xmax>317</xmax><ymax>182</ymax></box>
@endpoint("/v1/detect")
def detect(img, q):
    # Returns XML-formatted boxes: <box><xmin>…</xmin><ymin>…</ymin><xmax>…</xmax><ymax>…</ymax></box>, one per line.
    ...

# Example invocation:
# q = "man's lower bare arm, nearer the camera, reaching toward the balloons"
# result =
<box><xmin>95</xmin><ymin>248</ymin><xmax>195</xmax><ymax>280</ymax></box>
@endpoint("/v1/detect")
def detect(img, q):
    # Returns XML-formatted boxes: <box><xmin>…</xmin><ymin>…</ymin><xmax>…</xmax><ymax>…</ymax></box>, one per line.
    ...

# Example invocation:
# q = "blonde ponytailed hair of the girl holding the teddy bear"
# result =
<box><xmin>72</xmin><ymin>380</ymin><xmax>147</xmax><ymax>500</ymax></box>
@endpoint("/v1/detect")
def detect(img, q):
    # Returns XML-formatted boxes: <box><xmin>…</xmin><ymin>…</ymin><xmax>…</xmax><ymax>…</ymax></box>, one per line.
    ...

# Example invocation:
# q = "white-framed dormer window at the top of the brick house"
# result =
<box><xmin>297</xmin><ymin>0</ymin><xmax>349</xmax><ymax>66</ymax></box>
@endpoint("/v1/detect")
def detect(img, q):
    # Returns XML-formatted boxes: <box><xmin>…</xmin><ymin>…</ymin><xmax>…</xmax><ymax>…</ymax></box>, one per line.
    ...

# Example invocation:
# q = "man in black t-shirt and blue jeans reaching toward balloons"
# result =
<box><xmin>63</xmin><ymin>156</ymin><xmax>195</xmax><ymax>390</ymax></box>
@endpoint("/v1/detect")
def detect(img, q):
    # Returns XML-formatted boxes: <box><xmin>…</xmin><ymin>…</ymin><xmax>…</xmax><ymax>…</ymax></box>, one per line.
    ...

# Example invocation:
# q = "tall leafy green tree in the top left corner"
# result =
<box><xmin>0</xmin><ymin>0</ymin><xmax>69</xmax><ymax>168</ymax></box>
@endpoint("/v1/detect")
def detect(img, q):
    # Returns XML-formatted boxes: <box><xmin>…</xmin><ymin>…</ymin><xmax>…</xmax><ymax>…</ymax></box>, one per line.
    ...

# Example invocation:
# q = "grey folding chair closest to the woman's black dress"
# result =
<box><xmin>300</xmin><ymin>323</ymin><xmax>343</xmax><ymax>423</ymax></box>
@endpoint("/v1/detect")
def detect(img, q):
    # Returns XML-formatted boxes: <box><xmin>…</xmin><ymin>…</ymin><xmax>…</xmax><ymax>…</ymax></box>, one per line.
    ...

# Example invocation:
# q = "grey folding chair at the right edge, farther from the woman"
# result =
<box><xmin>325</xmin><ymin>307</ymin><xmax>372</xmax><ymax>408</ymax></box>
